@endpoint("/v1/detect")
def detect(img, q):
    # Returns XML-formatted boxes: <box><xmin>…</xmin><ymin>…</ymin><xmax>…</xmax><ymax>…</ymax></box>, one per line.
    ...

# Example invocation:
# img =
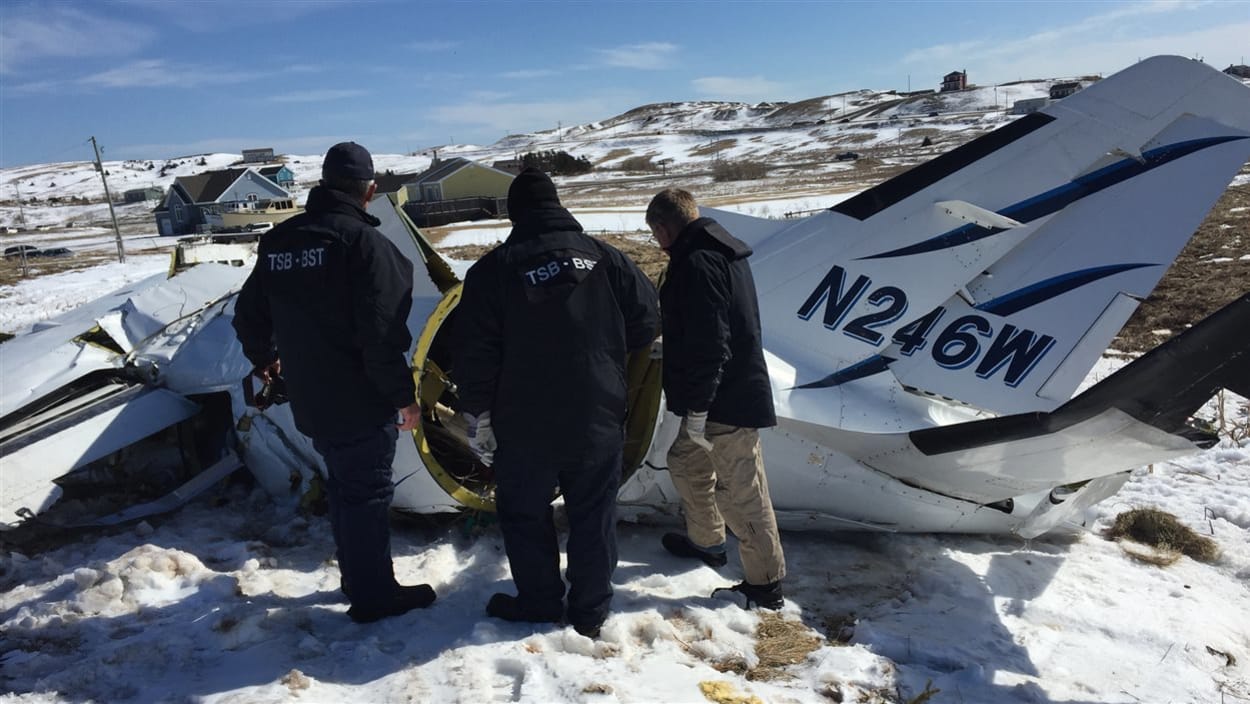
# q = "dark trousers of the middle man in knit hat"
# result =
<box><xmin>495</xmin><ymin>444</ymin><xmax>623</xmax><ymax>625</ymax></box>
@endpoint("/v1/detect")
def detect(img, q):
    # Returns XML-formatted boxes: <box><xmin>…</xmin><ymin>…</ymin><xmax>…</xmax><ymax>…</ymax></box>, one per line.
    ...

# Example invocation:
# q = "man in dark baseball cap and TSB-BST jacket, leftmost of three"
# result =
<box><xmin>234</xmin><ymin>141</ymin><xmax>435</xmax><ymax>623</ymax></box>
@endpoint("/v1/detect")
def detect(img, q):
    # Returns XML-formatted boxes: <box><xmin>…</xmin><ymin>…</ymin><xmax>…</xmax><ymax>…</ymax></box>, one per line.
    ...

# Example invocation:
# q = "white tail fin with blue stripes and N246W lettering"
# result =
<box><xmin>730</xmin><ymin>56</ymin><xmax>1250</xmax><ymax>413</ymax></box>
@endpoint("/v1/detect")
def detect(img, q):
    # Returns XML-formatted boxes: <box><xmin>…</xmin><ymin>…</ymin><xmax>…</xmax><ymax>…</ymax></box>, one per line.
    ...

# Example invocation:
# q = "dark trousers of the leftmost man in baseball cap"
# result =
<box><xmin>313</xmin><ymin>424</ymin><xmax>399</xmax><ymax>608</ymax></box>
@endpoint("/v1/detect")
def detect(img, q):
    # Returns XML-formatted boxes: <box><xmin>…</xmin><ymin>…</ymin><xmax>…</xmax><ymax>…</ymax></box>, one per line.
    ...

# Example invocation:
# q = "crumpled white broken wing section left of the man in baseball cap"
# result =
<box><xmin>0</xmin><ymin>265</ymin><xmax>246</xmax><ymax>528</ymax></box>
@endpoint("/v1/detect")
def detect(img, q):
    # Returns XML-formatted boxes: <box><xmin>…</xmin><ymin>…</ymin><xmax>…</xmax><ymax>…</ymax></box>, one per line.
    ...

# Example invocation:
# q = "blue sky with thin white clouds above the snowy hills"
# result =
<box><xmin>0</xmin><ymin>0</ymin><xmax>1250</xmax><ymax>166</ymax></box>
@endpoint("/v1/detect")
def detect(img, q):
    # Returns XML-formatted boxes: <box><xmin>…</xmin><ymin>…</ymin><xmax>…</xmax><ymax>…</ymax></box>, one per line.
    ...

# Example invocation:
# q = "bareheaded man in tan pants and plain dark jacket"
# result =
<box><xmin>646</xmin><ymin>189</ymin><xmax>785</xmax><ymax>609</ymax></box>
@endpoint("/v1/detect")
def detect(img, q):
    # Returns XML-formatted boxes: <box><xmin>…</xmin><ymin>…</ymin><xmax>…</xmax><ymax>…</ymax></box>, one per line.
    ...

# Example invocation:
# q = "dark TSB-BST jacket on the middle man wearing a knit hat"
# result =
<box><xmin>451</xmin><ymin>206</ymin><xmax>659</xmax><ymax>461</ymax></box>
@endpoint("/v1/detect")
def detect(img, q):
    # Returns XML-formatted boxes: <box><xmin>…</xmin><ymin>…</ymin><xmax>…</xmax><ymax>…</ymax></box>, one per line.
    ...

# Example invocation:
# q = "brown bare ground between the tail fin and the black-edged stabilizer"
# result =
<box><xmin>1111</xmin><ymin>181</ymin><xmax>1250</xmax><ymax>355</ymax></box>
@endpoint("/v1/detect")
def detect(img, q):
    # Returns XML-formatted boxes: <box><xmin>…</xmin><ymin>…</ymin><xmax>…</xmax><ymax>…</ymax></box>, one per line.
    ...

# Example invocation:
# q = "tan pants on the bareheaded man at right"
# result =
<box><xmin>669</xmin><ymin>419</ymin><xmax>785</xmax><ymax>584</ymax></box>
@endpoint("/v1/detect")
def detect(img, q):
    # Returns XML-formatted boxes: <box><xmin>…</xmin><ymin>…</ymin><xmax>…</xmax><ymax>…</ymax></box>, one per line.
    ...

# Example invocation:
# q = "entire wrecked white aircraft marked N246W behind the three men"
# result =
<box><xmin>0</xmin><ymin>56</ymin><xmax>1250</xmax><ymax>536</ymax></box>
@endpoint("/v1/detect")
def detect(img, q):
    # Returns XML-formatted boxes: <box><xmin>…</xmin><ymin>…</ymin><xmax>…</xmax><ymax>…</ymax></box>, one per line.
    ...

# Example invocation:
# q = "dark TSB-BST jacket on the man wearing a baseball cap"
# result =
<box><xmin>234</xmin><ymin>186</ymin><xmax>415</xmax><ymax>439</ymax></box>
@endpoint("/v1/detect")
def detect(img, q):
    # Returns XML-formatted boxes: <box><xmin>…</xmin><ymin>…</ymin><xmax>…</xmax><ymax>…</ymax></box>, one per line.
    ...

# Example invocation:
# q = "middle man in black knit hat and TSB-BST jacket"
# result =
<box><xmin>451</xmin><ymin>168</ymin><xmax>659</xmax><ymax>638</ymax></box>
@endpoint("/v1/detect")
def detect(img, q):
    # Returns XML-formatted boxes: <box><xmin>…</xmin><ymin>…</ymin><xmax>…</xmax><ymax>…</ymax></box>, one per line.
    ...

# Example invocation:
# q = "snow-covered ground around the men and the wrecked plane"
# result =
<box><xmin>0</xmin><ymin>243</ymin><xmax>1250</xmax><ymax>704</ymax></box>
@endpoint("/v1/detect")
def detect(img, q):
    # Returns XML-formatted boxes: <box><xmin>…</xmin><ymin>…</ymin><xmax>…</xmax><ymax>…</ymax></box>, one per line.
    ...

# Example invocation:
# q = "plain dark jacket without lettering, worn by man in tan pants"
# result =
<box><xmin>660</xmin><ymin>218</ymin><xmax>776</xmax><ymax>428</ymax></box>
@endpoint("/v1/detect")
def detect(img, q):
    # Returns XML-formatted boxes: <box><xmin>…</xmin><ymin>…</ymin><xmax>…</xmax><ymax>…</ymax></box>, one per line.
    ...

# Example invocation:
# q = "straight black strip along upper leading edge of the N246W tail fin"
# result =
<box><xmin>830</xmin><ymin>113</ymin><xmax>1055</xmax><ymax>220</ymax></box>
